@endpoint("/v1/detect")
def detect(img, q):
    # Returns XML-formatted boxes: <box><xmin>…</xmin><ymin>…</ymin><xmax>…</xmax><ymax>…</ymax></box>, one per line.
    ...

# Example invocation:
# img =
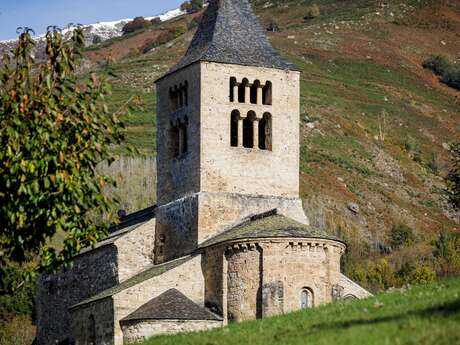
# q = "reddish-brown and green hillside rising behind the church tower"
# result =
<box><xmin>78</xmin><ymin>0</ymin><xmax>460</xmax><ymax>284</ymax></box>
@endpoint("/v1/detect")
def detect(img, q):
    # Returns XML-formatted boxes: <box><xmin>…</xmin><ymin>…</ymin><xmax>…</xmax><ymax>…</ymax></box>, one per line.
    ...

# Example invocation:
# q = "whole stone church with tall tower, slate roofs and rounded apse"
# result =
<box><xmin>37</xmin><ymin>0</ymin><xmax>369</xmax><ymax>345</ymax></box>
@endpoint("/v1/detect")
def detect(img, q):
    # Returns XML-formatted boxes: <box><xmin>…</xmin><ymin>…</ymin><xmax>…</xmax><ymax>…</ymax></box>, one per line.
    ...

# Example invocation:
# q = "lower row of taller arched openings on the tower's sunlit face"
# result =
<box><xmin>230</xmin><ymin>110</ymin><xmax>272</xmax><ymax>151</ymax></box>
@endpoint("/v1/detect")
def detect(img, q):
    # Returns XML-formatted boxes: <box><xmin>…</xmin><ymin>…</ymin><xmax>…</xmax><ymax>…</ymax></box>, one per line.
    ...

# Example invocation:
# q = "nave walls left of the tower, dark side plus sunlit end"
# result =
<box><xmin>37</xmin><ymin>219</ymin><xmax>155</xmax><ymax>345</ymax></box>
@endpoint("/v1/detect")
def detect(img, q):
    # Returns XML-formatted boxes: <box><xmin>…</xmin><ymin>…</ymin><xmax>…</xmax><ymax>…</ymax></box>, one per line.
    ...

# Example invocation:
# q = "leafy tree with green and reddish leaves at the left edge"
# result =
<box><xmin>0</xmin><ymin>28</ymin><xmax>124</xmax><ymax>293</ymax></box>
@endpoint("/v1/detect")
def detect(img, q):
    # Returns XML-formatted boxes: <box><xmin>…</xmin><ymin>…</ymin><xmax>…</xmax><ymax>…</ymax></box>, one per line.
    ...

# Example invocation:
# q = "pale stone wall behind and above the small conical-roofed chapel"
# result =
<box><xmin>113</xmin><ymin>255</ymin><xmax>205</xmax><ymax>345</ymax></box>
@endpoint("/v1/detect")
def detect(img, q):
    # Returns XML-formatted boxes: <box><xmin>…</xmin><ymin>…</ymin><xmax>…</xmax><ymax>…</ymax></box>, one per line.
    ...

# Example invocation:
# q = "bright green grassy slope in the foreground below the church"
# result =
<box><xmin>142</xmin><ymin>279</ymin><xmax>460</xmax><ymax>345</ymax></box>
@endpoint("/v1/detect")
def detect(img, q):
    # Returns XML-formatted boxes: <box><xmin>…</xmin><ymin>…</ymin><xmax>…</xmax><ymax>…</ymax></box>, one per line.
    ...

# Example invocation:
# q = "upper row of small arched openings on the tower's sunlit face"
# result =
<box><xmin>229</xmin><ymin>77</ymin><xmax>272</xmax><ymax>105</ymax></box>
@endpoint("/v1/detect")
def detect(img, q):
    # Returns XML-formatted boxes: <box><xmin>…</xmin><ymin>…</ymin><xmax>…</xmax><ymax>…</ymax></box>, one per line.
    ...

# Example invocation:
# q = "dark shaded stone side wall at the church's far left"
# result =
<box><xmin>36</xmin><ymin>245</ymin><xmax>118</xmax><ymax>345</ymax></box>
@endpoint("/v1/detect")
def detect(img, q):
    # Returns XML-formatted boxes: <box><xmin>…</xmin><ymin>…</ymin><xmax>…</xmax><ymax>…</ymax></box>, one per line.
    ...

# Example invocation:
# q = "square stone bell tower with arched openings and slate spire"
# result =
<box><xmin>155</xmin><ymin>0</ymin><xmax>308</xmax><ymax>263</ymax></box>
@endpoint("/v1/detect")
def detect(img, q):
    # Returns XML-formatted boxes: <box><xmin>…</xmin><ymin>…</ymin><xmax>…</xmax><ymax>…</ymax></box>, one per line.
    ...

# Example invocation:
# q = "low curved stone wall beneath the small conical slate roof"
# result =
<box><xmin>122</xmin><ymin>320</ymin><xmax>222</xmax><ymax>345</ymax></box>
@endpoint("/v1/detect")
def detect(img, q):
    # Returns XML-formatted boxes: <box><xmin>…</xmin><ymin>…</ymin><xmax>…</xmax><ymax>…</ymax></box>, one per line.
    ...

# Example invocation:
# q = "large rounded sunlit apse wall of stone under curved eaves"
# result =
<box><xmin>206</xmin><ymin>239</ymin><xmax>345</xmax><ymax>321</ymax></box>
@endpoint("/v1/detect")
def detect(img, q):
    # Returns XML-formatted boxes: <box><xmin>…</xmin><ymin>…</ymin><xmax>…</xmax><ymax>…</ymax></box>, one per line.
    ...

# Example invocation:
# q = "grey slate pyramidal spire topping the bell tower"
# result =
<box><xmin>168</xmin><ymin>0</ymin><xmax>298</xmax><ymax>74</ymax></box>
